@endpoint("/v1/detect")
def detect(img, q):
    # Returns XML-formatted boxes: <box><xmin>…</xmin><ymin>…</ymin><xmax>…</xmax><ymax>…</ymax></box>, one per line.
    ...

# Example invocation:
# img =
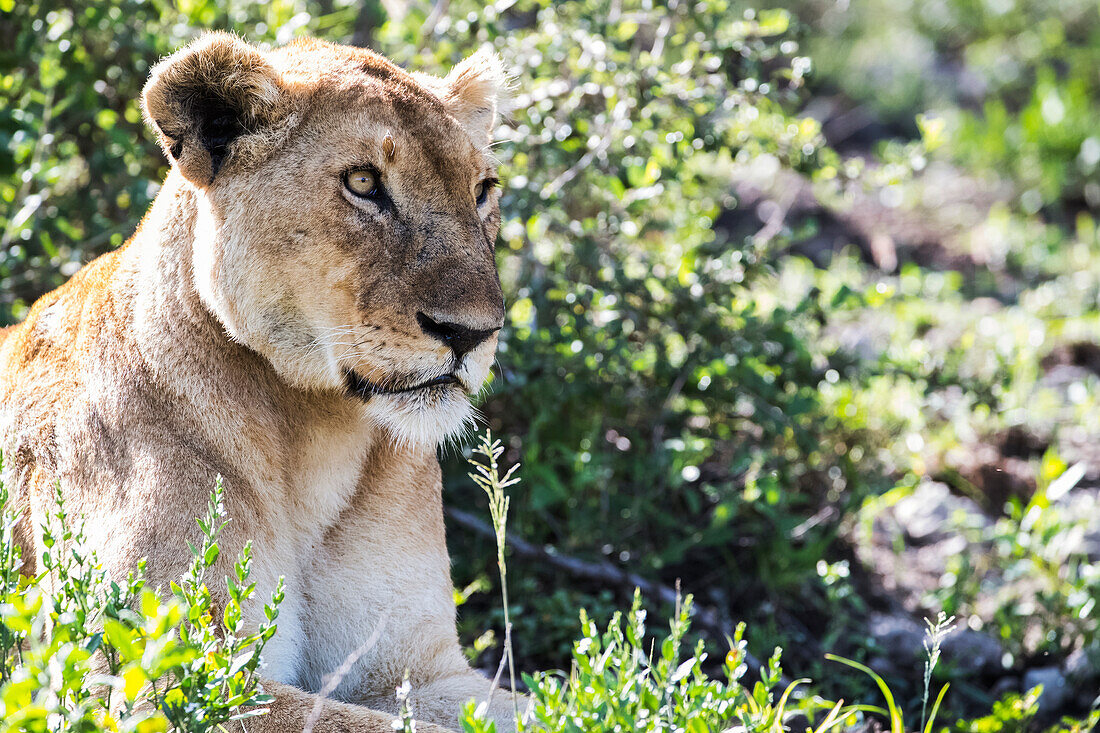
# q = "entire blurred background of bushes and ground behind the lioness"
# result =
<box><xmin>0</xmin><ymin>0</ymin><xmax>1100</xmax><ymax>730</ymax></box>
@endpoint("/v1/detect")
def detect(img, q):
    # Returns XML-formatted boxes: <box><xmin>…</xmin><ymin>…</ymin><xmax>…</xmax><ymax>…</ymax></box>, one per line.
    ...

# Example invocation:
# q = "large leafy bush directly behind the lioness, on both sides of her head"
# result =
<box><xmin>0</xmin><ymin>0</ymin><xmax>870</xmax><ymax>704</ymax></box>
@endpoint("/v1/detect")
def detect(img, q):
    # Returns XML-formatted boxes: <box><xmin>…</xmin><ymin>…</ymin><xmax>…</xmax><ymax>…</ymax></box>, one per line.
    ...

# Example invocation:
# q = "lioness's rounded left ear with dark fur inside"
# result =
<box><xmin>142</xmin><ymin>32</ymin><xmax>288</xmax><ymax>186</ymax></box>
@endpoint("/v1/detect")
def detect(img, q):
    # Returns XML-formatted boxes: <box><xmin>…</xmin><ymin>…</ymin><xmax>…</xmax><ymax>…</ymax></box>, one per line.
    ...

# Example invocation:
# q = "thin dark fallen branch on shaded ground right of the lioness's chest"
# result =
<box><xmin>447</xmin><ymin>506</ymin><xmax>791</xmax><ymax>687</ymax></box>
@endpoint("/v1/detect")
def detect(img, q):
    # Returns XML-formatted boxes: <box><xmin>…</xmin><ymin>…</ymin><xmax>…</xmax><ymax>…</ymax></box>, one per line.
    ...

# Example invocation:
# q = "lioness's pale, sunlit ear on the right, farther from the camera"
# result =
<box><xmin>442</xmin><ymin>48</ymin><xmax>510</xmax><ymax>144</ymax></box>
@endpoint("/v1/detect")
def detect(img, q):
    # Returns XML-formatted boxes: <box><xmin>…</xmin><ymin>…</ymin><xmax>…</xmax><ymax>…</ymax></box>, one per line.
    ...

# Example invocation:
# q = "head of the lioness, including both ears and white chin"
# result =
<box><xmin>143</xmin><ymin>33</ymin><xmax>506</xmax><ymax>442</ymax></box>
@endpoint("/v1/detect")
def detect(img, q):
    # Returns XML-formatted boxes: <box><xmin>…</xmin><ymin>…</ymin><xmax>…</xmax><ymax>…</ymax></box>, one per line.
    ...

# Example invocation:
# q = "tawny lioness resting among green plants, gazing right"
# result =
<box><xmin>0</xmin><ymin>33</ymin><xmax>514</xmax><ymax>733</ymax></box>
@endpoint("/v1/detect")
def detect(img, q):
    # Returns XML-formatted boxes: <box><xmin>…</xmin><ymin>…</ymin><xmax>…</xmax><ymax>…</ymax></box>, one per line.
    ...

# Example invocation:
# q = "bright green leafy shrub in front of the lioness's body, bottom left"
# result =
<box><xmin>0</xmin><ymin>477</ymin><xmax>282</xmax><ymax>733</ymax></box>
